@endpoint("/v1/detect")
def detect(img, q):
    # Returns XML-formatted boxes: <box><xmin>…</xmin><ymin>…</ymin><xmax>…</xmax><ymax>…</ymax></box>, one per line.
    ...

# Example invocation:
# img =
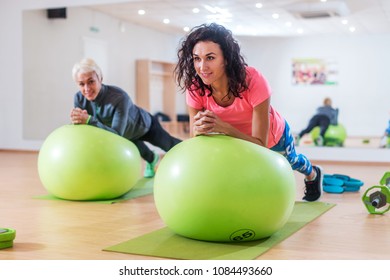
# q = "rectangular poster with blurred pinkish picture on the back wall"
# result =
<box><xmin>292</xmin><ymin>58</ymin><xmax>338</xmax><ymax>85</ymax></box>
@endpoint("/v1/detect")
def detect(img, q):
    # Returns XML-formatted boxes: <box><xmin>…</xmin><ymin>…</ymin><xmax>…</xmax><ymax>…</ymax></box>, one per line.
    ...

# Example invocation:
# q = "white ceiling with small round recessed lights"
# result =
<box><xmin>90</xmin><ymin>0</ymin><xmax>390</xmax><ymax>36</ymax></box>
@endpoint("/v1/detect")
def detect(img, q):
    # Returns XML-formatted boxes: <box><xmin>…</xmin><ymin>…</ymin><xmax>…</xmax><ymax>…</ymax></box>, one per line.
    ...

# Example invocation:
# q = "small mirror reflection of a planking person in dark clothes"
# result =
<box><xmin>295</xmin><ymin>97</ymin><xmax>339</xmax><ymax>146</ymax></box>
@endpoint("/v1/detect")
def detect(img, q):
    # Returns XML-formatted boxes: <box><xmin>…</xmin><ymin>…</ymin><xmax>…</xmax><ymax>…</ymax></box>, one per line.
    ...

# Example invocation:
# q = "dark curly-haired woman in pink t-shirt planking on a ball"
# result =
<box><xmin>175</xmin><ymin>23</ymin><xmax>323</xmax><ymax>201</ymax></box>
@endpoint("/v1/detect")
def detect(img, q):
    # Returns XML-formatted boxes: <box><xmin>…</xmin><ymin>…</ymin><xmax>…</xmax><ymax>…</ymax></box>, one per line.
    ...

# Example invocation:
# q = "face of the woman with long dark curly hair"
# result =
<box><xmin>192</xmin><ymin>41</ymin><xmax>227</xmax><ymax>87</ymax></box>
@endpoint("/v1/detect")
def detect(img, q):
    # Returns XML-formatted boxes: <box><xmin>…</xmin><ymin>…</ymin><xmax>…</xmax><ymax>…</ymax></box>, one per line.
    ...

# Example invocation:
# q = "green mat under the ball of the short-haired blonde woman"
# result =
<box><xmin>34</xmin><ymin>178</ymin><xmax>154</xmax><ymax>204</ymax></box>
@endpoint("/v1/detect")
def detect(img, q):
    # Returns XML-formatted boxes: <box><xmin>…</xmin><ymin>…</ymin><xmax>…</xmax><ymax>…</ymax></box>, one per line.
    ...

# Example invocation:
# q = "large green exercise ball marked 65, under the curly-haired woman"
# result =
<box><xmin>154</xmin><ymin>135</ymin><xmax>296</xmax><ymax>242</ymax></box>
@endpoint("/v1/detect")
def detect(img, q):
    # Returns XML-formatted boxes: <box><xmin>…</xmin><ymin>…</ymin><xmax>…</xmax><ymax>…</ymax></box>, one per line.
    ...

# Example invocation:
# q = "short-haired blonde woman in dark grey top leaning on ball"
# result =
<box><xmin>70</xmin><ymin>58</ymin><xmax>181</xmax><ymax>178</ymax></box>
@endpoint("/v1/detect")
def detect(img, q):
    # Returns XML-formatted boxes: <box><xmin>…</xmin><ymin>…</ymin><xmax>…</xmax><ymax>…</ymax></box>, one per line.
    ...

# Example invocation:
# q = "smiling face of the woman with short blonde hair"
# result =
<box><xmin>76</xmin><ymin>72</ymin><xmax>102</xmax><ymax>101</ymax></box>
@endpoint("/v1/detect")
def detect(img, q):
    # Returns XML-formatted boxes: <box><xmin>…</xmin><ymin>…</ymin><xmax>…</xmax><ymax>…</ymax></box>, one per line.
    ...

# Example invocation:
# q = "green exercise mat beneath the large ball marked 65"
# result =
<box><xmin>103</xmin><ymin>202</ymin><xmax>335</xmax><ymax>260</ymax></box>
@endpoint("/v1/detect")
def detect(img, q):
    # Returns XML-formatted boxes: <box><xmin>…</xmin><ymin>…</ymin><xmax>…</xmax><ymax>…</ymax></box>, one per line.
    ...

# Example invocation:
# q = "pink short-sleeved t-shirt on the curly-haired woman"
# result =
<box><xmin>186</xmin><ymin>67</ymin><xmax>285</xmax><ymax>148</ymax></box>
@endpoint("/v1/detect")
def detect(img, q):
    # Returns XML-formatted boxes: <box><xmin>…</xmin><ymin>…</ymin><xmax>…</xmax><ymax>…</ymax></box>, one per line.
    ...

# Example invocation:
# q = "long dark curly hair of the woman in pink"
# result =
<box><xmin>175</xmin><ymin>23</ymin><xmax>248</xmax><ymax>98</ymax></box>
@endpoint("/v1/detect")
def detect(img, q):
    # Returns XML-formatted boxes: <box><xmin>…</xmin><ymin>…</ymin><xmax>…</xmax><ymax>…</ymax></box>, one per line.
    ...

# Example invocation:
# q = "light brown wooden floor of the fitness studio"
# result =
<box><xmin>0</xmin><ymin>151</ymin><xmax>390</xmax><ymax>260</ymax></box>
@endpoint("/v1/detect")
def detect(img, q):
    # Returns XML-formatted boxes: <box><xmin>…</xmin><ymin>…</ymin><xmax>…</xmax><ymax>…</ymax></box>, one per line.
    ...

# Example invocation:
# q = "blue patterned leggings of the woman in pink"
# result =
<box><xmin>271</xmin><ymin>122</ymin><xmax>313</xmax><ymax>176</ymax></box>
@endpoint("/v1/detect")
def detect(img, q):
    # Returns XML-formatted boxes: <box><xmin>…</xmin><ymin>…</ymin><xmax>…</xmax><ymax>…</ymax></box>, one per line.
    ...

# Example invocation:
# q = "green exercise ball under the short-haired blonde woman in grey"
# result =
<box><xmin>38</xmin><ymin>125</ymin><xmax>141</xmax><ymax>200</ymax></box>
